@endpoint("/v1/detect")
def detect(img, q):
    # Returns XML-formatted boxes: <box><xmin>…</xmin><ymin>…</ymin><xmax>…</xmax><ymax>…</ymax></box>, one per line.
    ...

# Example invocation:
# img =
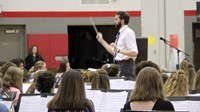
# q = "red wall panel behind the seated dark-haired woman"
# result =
<box><xmin>27</xmin><ymin>34</ymin><xmax>68</xmax><ymax>68</ymax></box>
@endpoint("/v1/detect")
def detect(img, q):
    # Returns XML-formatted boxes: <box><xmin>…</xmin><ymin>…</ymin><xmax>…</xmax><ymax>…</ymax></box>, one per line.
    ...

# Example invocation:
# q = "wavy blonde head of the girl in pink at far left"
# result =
<box><xmin>3</xmin><ymin>66</ymin><xmax>23</xmax><ymax>92</ymax></box>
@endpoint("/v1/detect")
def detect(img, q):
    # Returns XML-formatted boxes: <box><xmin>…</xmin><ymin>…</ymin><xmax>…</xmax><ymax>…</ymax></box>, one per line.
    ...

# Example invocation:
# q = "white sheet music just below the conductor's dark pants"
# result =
<box><xmin>110</xmin><ymin>79</ymin><xmax>135</xmax><ymax>90</ymax></box>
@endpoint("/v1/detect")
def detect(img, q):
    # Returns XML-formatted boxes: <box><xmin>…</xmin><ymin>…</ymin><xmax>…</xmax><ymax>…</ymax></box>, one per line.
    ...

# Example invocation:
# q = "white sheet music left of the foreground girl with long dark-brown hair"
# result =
<box><xmin>19</xmin><ymin>95</ymin><xmax>53</xmax><ymax>112</ymax></box>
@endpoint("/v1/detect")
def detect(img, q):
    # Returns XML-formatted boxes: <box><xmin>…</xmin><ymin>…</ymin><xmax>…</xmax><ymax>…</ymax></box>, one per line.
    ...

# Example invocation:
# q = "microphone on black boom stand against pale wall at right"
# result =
<box><xmin>161</xmin><ymin>38</ymin><xmax>190</xmax><ymax>70</ymax></box>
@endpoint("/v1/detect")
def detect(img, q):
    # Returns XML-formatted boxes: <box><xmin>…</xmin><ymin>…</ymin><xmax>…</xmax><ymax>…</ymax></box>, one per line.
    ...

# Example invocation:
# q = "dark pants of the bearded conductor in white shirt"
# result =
<box><xmin>116</xmin><ymin>58</ymin><xmax>135</xmax><ymax>77</ymax></box>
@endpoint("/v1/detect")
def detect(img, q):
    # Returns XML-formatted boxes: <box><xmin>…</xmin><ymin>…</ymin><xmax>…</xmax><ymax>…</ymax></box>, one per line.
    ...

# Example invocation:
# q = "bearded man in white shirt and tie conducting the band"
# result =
<box><xmin>96</xmin><ymin>11</ymin><xmax>138</xmax><ymax>77</ymax></box>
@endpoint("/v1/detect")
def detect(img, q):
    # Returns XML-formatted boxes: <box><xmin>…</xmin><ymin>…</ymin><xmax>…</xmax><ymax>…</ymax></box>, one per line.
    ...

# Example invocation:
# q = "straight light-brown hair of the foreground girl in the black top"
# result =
<box><xmin>130</xmin><ymin>67</ymin><xmax>164</xmax><ymax>101</ymax></box>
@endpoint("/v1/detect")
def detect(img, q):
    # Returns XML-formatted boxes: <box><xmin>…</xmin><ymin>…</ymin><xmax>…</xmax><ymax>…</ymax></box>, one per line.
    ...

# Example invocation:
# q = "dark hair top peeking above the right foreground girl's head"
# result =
<box><xmin>135</xmin><ymin>61</ymin><xmax>161</xmax><ymax>76</ymax></box>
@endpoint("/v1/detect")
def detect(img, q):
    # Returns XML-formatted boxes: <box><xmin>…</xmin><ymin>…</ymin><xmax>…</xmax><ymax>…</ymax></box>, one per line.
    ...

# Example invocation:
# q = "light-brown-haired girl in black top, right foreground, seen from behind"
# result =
<box><xmin>124</xmin><ymin>67</ymin><xmax>174</xmax><ymax>112</ymax></box>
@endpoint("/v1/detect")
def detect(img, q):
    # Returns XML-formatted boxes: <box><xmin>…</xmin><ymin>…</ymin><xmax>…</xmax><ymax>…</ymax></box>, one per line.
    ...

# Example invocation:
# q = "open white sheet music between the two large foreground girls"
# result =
<box><xmin>86</xmin><ymin>90</ymin><xmax>128</xmax><ymax>112</ymax></box>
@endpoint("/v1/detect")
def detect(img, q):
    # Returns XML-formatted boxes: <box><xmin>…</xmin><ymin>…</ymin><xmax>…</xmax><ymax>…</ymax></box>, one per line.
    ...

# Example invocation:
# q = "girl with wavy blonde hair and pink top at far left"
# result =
<box><xmin>2</xmin><ymin>66</ymin><xmax>23</xmax><ymax>103</ymax></box>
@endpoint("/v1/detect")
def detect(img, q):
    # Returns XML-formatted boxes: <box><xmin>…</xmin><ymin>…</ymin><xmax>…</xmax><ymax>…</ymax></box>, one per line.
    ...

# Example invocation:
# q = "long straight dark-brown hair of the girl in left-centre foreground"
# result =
<box><xmin>48</xmin><ymin>70</ymin><xmax>86</xmax><ymax>109</ymax></box>
